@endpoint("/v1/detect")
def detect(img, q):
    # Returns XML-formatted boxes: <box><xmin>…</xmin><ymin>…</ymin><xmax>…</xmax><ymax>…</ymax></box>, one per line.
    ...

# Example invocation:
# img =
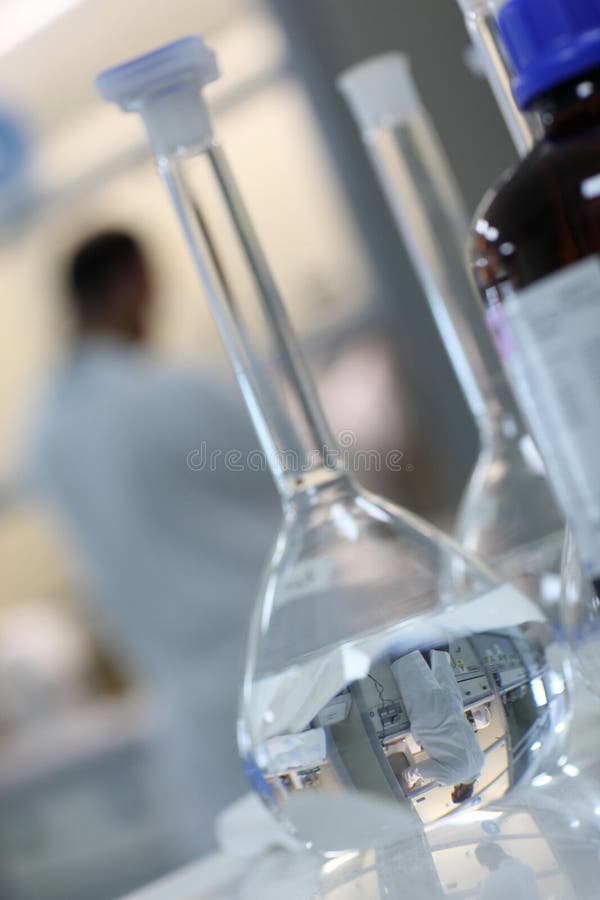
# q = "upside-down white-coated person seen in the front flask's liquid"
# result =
<box><xmin>391</xmin><ymin>650</ymin><xmax>485</xmax><ymax>803</ymax></box>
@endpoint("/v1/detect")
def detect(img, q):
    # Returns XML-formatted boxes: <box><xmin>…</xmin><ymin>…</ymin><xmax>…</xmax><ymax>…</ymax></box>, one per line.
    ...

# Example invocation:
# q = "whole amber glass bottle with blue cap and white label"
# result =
<box><xmin>471</xmin><ymin>0</ymin><xmax>600</xmax><ymax>586</ymax></box>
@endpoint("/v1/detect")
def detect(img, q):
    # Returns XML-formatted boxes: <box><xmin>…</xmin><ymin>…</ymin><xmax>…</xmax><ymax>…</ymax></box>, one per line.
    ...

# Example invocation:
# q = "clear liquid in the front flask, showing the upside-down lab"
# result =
<box><xmin>252</xmin><ymin>620</ymin><xmax>568</xmax><ymax>849</ymax></box>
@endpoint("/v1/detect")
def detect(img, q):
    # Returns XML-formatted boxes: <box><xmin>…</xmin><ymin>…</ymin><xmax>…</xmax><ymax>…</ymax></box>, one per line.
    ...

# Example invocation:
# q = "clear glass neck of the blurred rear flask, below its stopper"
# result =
<box><xmin>364</xmin><ymin>116</ymin><xmax>520</xmax><ymax>443</ymax></box>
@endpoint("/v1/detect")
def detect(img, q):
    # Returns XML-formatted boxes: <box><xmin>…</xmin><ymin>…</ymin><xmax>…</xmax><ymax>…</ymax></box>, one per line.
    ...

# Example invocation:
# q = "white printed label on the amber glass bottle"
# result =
<box><xmin>503</xmin><ymin>257</ymin><xmax>600</xmax><ymax>576</ymax></box>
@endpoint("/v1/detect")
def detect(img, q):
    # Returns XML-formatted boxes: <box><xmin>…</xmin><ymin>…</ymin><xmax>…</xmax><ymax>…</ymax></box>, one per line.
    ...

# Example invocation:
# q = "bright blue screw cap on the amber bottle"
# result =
<box><xmin>498</xmin><ymin>0</ymin><xmax>600</xmax><ymax>109</ymax></box>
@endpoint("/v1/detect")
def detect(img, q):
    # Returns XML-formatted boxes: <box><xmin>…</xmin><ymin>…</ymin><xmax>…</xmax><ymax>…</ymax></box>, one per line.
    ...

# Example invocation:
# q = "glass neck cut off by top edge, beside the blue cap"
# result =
<box><xmin>458</xmin><ymin>0</ymin><xmax>540</xmax><ymax>156</ymax></box>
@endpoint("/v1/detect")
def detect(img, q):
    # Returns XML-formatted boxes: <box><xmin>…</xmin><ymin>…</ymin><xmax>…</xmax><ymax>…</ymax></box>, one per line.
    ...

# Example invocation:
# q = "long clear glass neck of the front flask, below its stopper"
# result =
<box><xmin>157</xmin><ymin>142</ymin><xmax>349</xmax><ymax>505</ymax></box>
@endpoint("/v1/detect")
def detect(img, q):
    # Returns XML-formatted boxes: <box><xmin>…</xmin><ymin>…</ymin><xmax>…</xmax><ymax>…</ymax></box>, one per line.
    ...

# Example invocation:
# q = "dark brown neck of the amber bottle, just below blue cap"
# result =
<box><xmin>532</xmin><ymin>67</ymin><xmax>600</xmax><ymax>140</ymax></box>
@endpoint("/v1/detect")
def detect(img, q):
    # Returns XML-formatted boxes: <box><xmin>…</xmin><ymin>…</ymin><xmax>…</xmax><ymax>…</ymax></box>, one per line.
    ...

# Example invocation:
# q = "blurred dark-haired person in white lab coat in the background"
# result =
<box><xmin>16</xmin><ymin>231</ymin><xmax>279</xmax><ymax>859</ymax></box>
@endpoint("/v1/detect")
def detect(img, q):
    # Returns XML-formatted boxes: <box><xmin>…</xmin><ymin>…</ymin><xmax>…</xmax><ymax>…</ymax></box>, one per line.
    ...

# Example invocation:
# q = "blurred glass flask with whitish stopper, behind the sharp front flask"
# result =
<box><xmin>338</xmin><ymin>53</ymin><xmax>564</xmax><ymax>622</ymax></box>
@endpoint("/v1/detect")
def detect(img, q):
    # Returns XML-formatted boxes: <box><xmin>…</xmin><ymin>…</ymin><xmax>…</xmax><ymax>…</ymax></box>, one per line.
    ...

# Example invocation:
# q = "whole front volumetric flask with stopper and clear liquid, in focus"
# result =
<box><xmin>98</xmin><ymin>37</ymin><xmax>569</xmax><ymax>851</ymax></box>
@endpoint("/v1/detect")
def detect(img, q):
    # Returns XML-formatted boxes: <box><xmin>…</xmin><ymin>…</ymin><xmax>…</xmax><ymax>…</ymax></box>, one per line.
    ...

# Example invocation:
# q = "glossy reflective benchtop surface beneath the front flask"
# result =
<box><xmin>238</xmin><ymin>770</ymin><xmax>600</xmax><ymax>900</ymax></box>
